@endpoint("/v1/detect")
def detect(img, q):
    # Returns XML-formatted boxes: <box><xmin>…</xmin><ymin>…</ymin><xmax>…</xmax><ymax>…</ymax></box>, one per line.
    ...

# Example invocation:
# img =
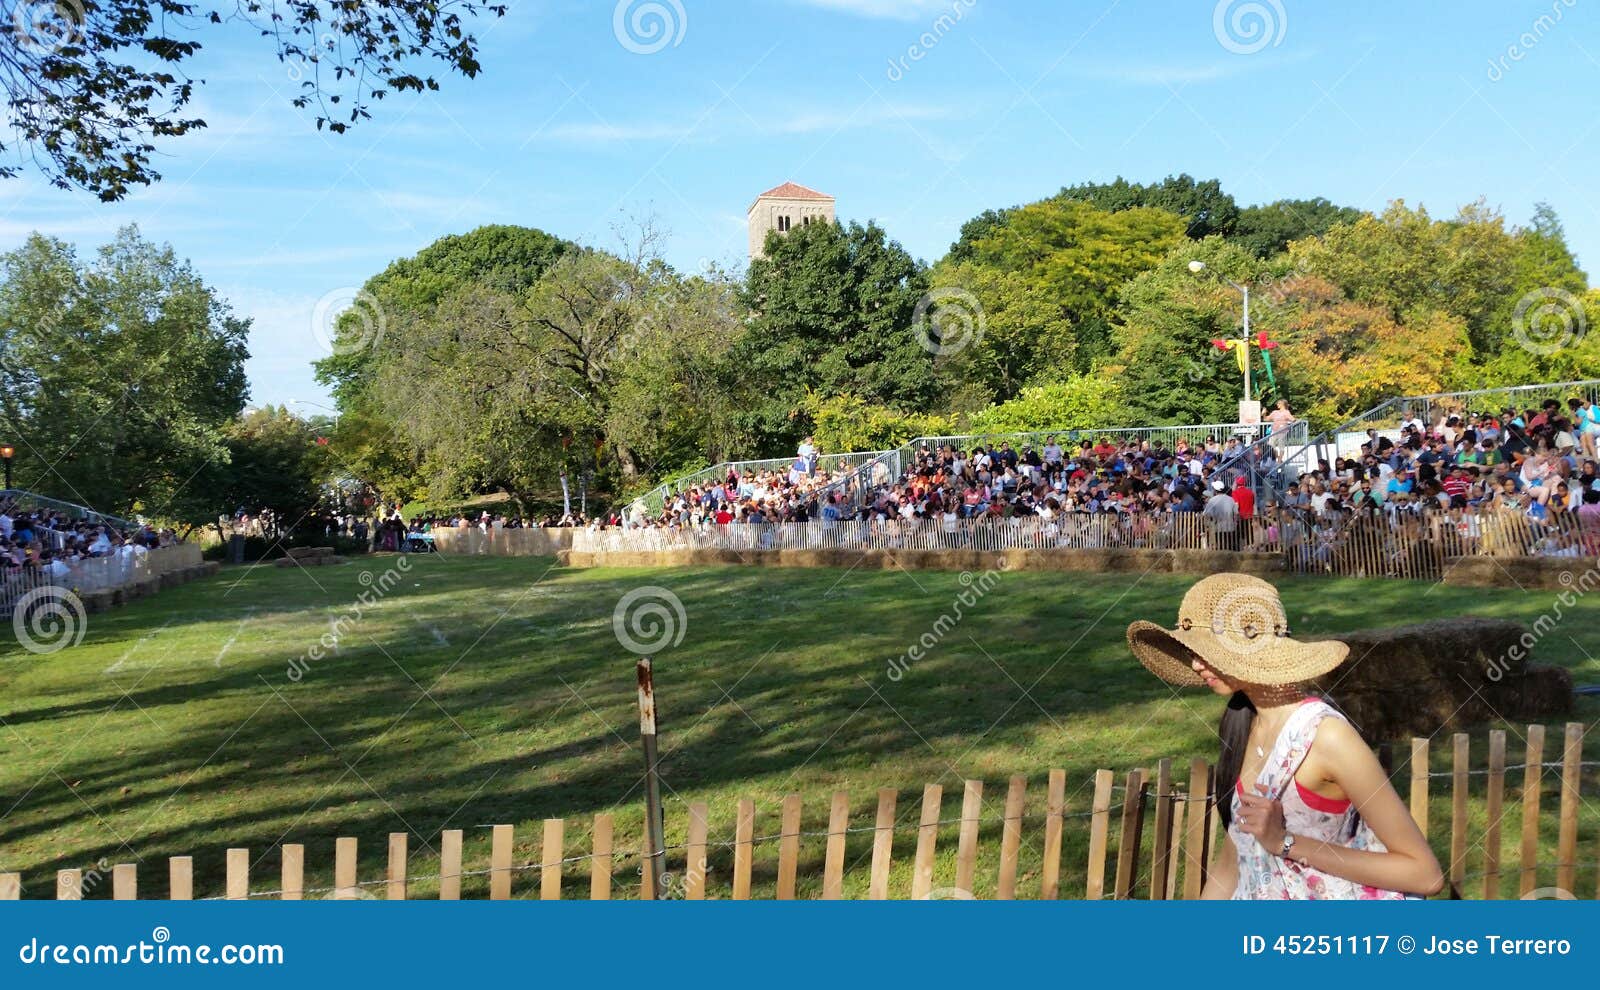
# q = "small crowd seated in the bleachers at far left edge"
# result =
<box><xmin>0</xmin><ymin>499</ymin><xmax>181</xmax><ymax>581</ymax></box>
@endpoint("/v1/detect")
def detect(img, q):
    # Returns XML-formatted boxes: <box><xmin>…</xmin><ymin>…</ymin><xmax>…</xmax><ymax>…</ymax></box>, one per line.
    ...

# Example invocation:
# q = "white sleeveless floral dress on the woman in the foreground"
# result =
<box><xmin>1227</xmin><ymin>697</ymin><xmax>1405</xmax><ymax>900</ymax></box>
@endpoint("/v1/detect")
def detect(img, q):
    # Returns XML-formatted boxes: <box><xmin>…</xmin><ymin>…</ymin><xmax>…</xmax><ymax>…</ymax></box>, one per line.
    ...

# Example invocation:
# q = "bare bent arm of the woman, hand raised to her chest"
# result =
<box><xmin>1245</xmin><ymin>718</ymin><xmax>1445</xmax><ymax>896</ymax></box>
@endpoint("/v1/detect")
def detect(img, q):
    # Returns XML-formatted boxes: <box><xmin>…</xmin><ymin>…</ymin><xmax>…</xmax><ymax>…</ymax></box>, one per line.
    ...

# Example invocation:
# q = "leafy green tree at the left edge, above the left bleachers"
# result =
<box><xmin>0</xmin><ymin>227</ymin><xmax>250</xmax><ymax>515</ymax></box>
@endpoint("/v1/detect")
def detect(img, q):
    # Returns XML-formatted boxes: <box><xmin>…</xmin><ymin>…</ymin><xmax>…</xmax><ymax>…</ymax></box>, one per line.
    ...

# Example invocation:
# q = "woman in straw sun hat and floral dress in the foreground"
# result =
<box><xmin>1128</xmin><ymin>574</ymin><xmax>1445</xmax><ymax>900</ymax></box>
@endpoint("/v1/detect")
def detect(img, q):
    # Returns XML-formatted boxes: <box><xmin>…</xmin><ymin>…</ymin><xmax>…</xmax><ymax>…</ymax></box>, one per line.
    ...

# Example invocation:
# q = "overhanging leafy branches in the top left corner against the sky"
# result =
<box><xmin>0</xmin><ymin>0</ymin><xmax>506</xmax><ymax>202</ymax></box>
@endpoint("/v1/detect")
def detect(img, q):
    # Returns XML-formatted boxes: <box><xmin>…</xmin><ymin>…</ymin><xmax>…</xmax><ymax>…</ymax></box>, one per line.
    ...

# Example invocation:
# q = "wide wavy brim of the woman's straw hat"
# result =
<box><xmin>1128</xmin><ymin>619</ymin><xmax>1350</xmax><ymax>688</ymax></box>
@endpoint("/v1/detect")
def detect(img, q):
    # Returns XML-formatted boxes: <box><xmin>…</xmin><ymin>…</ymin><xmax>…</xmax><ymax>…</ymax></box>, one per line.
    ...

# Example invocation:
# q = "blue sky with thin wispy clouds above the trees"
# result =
<box><xmin>0</xmin><ymin>0</ymin><xmax>1600</xmax><ymax>411</ymax></box>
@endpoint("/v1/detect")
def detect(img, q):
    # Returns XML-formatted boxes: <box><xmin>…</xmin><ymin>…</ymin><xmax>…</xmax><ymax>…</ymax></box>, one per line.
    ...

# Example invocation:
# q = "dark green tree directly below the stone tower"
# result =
<box><xmin>734</xmin><ymin>222</ymin><xmax>938</xmax><ymax>453</ymax></box>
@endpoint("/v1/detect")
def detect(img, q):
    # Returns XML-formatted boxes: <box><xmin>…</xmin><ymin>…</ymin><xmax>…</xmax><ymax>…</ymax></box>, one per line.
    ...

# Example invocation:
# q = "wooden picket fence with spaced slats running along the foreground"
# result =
<box><xmin>0</xmin><ymin>723</ymin><xmax>1600</xmax><ymax>900</ymax></box>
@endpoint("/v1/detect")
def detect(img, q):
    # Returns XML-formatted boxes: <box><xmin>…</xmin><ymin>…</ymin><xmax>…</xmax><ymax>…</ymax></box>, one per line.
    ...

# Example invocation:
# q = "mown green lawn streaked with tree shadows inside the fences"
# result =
<box><xmin>0</xmin><ymin>555</ymin><xmax>1600</xmax><ymax>897</ymax></box>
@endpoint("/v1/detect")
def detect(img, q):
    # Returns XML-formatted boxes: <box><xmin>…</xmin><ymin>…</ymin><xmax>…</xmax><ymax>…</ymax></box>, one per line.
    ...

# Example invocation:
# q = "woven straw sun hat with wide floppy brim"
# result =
<box><xmin>1128</xmin><ymin>574</ymin><xmax>1350</xmax><ymax>688</ymax></box>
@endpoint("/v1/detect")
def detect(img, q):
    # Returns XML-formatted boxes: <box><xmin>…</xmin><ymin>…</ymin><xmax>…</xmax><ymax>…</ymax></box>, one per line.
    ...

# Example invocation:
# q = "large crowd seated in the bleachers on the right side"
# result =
<box><xmin>600</xmin><ymin>397</ymin><xmax>1600</xmax><ymax>563</ymax></box>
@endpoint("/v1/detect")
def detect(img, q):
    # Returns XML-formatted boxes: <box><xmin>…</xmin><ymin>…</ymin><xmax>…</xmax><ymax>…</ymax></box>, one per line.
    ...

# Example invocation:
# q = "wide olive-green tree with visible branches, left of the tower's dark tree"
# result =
<box><xmin>360</xmin><ymin>239</ymin><xmax>739</xmax><ymax>504</ymax></box>
